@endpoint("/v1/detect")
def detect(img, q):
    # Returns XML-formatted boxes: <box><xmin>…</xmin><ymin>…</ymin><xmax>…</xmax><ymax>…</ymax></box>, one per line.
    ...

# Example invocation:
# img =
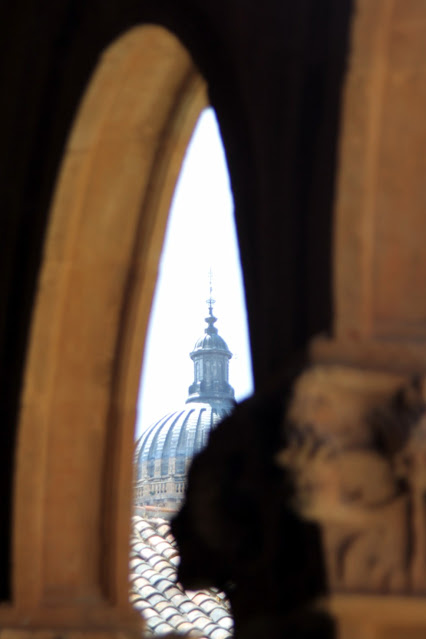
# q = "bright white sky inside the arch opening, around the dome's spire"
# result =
<box><xmin>136</xmin><ymin>108</ymin><xmax>253</xmax><ymax>435</ymax></box>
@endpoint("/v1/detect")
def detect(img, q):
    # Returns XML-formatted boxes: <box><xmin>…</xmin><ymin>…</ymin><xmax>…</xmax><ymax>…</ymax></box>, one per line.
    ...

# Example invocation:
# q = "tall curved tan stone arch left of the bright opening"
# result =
<box><xmin>10</xmin><ymin>26</ymin><xmax>207</xmax><ymax>628</ymax></box>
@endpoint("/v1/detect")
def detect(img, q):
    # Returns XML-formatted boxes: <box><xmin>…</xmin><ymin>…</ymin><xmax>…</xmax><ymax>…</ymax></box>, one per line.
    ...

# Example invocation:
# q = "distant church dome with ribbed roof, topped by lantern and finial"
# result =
<box><xmin>135</xmin><ymin>291</ymin><xmax>235</xmax><ymax>513</ymax></box>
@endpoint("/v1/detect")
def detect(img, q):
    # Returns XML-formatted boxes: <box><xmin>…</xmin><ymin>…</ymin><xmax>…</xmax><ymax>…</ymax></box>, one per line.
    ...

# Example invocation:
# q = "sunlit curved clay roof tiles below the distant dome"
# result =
<box><xmin>130</xmin><ymin>516</ymin><xmax>233</xmax><ymax>639</ymax></box>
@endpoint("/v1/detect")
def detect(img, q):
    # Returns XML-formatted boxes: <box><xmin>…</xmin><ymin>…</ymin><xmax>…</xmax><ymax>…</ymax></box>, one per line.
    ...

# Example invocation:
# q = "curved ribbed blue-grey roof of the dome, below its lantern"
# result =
<box><xmin>136</xmin><ymin>403</ymin><xmax>230</xmax><ymax>480</ymax></box>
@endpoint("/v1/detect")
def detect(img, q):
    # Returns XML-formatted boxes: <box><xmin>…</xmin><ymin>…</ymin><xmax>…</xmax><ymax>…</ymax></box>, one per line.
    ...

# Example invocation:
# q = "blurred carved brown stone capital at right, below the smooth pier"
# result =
<box><xmin>277</xmin><ymin>368</ymin><xmax>426</xmax><ymax>593</ymax></box>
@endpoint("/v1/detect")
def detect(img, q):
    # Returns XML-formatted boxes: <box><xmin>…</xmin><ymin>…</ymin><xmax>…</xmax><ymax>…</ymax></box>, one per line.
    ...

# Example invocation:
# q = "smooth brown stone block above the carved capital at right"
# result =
<box><xmin>334</xmin><ymin>0</ymin><xmax>426</xmax><ymax>348</ymax></box>
